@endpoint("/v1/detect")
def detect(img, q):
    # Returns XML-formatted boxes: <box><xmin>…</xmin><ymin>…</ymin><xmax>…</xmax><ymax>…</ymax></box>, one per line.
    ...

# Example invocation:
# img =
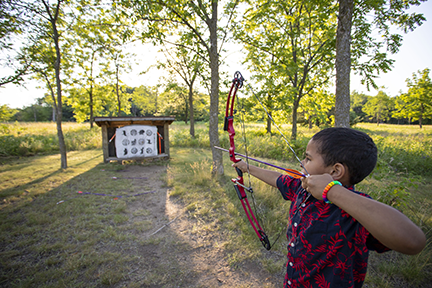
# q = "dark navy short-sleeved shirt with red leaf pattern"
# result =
<box><xmin>277</xmin><ymin>175</ymin><xmax>389</xmax><ymax>288</ymax></box>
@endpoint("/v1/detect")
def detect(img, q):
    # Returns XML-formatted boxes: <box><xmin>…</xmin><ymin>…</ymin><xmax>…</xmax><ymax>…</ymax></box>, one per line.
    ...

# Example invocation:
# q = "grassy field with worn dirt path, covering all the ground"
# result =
<box><xmin>0</xmin><ymin>123</ymin><xmax>432</xmax><ymax>287</ymax></box>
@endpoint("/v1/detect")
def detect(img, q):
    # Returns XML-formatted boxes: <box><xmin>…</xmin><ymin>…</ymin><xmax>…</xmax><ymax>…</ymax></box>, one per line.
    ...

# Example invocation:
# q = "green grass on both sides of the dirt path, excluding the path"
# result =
<box><xmin>0</xmin><ymin>123</ymin><xmax>432</xmax><ymax>287</ymax></box>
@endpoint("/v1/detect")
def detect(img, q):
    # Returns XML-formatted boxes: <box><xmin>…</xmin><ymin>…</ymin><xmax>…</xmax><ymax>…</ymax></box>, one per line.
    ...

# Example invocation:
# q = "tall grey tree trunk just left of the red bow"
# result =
<box><xmin>207</xmin><ymin>1</ymin><xmax>224</xmax><ymax>175</ymax></box>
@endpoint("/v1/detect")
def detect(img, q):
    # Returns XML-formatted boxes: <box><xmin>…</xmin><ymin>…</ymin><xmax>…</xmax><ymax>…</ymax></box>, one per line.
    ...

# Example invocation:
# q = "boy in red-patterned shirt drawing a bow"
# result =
<box><xmin>233</xmin><ymin>128</ymin><xmax>426</xmax><ymax>288</ymax></box>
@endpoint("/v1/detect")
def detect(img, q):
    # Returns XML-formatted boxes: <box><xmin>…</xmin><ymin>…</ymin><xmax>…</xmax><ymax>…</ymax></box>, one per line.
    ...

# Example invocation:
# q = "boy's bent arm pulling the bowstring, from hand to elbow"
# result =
<box><xmin>302</xmin><ymin>174</ymin><xmax>426</xmax><ymax>255</ymax></box>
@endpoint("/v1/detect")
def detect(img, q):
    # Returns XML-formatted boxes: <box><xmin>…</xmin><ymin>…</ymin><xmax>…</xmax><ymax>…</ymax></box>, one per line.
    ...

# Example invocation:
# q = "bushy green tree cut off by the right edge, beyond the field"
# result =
<box><xmin>395</xmin><ymin>68</ymin><xmax>432</xmax><ymax>128</ymax></box>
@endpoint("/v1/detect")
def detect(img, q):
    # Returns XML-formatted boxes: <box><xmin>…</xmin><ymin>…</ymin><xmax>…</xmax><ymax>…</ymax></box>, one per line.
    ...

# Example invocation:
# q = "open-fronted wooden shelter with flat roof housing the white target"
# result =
<box><xmin>94</xmin><ymin>116</ymin><xmax>175</xmax><ymax>162</ymax></box>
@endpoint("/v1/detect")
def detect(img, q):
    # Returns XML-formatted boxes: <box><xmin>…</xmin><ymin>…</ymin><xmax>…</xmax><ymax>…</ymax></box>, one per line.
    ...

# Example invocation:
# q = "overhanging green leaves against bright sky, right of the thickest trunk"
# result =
<box><xmin>351</xmin><ymin>0</ymin><xmax>426</xmax><ymax>89</ymax></box>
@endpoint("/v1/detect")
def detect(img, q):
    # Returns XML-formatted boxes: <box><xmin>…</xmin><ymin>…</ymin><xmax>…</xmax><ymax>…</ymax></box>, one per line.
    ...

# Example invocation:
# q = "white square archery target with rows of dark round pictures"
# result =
<box><xmin>115</xmin><ymin>125</ymin><xmax>158</xmax><ymax>159</ymax></box>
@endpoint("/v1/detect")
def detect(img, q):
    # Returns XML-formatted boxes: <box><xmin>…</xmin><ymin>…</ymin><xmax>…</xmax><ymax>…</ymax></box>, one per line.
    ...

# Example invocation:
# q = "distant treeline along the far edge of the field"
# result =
<box><xmin>0</xmin><ymin>81</ymin><xmax>432</xmax><ymax>127</ymax></box>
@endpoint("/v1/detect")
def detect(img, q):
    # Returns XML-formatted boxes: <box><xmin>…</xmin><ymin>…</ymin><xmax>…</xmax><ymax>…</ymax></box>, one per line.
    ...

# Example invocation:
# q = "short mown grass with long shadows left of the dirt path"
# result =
<box><xmin>0</xmin><ymin>150</ymin><xmax>137</xmax><ymax>287</ymax></box>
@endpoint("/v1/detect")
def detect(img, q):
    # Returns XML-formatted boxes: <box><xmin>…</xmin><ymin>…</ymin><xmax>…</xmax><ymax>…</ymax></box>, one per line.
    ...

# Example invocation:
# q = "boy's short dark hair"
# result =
<box><xmin>312</xmin><ymin>127</ymin><xmax>378</xmax><ymax>185</ymax></box>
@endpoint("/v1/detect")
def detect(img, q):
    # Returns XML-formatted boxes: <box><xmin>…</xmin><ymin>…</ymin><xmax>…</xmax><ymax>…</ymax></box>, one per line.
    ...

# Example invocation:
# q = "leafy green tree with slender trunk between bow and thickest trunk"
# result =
<box><xmin>236</xmin><ymin>0</ymin><xmax>336</xmax><ymax>139</ymax></box>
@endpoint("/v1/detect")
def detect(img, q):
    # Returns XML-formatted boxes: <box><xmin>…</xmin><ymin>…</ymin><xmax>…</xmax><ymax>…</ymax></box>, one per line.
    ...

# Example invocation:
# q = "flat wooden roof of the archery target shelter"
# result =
<box><xmin>94</xmin><ymin>116</ymin><xmax>175</xmax><ymax>127</ymax></box>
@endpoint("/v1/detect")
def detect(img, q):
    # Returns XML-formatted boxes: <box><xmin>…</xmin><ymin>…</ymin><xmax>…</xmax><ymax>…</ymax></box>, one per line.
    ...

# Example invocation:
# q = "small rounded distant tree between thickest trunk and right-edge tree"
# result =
<box><xmin>363</xmin><ymin>91</ymin><xmax>393</xmax><ymax>125</ymax></box>
